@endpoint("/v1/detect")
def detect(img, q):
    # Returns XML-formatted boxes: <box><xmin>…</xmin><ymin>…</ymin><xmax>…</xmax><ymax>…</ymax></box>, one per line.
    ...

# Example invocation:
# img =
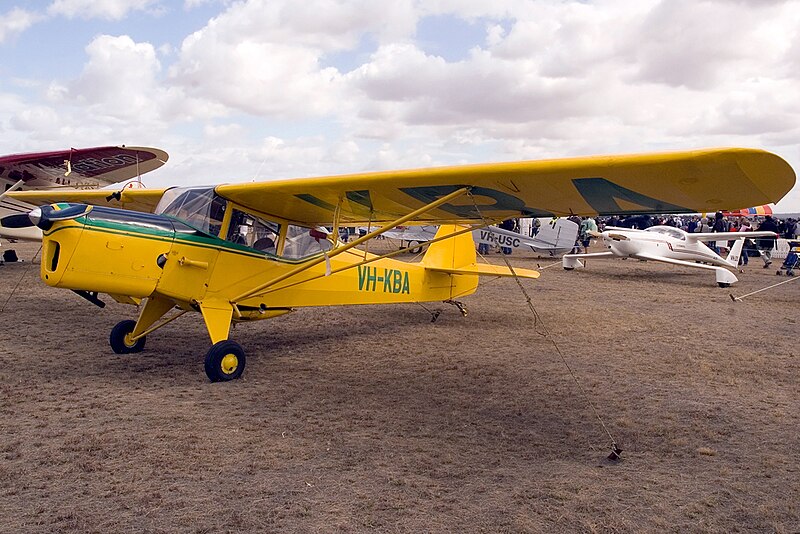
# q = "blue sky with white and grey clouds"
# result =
<box><xmin>0</xmin><ymin>0</ymin><xmax>800</xmax><ymax>212</ymax></box>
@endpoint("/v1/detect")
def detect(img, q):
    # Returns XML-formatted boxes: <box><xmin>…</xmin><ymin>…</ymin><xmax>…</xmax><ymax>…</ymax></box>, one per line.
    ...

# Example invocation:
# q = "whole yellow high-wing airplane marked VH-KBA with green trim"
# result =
<box><xmin>9</xmin><ymin>149</ymin><xmax>795</xmax><ymax>381</ymax></box>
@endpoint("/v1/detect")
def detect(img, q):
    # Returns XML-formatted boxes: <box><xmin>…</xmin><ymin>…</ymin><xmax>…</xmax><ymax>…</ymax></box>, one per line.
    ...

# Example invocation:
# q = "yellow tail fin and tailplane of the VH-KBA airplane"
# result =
<box><xmin>422</xmin><ymin>224</ymin><xmax>539</xmax><ymax>278</ymax></box>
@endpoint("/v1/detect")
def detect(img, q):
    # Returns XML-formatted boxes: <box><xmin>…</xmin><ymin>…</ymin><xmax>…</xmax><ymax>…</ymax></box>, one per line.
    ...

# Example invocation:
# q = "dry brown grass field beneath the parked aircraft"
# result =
<box><xmin>0</xmin><ymin>244</ymin><xmax>800</xmax><ymax>533</ymax></box>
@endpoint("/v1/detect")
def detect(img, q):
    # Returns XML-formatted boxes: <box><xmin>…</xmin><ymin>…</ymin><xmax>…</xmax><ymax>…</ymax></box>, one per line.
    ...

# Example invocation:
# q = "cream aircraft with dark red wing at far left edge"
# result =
<box><xmin>0</xmin><ymin>146</ymin><xmax>169</xmax><ymax>241</ymax></box>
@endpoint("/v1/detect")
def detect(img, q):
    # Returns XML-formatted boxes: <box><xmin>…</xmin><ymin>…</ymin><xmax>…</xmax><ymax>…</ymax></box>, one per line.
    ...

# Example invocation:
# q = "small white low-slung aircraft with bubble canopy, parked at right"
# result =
<box><xmin>561</xmin><ymin>226</ymin><xmax>776</xmax><ymax>287</ymax></box>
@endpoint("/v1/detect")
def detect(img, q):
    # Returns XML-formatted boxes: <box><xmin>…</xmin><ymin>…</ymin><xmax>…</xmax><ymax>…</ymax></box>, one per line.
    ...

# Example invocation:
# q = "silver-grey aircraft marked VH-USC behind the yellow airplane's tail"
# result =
<box><xmin>383</xmin><ymin>219</ymin><xmax>578</xmax><ymax>257</ymax></box>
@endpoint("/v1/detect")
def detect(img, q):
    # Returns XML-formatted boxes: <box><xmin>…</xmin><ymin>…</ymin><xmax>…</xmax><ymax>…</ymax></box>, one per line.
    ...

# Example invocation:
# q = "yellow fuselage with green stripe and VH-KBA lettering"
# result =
<box><xmin>41</xmin><ymin>209</ymin><xmax>478</xmax><ymax>320</ymax></box>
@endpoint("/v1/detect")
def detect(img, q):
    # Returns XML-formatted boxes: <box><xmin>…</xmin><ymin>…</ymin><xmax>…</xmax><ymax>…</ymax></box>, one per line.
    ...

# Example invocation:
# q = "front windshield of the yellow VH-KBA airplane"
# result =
<box><xmin>155</xmin><ymin>187</ymin><xmax>227</xmax><ymax>236</ymax></box>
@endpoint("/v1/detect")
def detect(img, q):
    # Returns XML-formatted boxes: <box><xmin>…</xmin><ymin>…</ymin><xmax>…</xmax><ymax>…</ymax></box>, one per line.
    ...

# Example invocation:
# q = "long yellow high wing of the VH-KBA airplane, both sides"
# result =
<box><xmin>10</xmin><ymin>148</ymin><xmax>795</xmax><ymax>226</ymax></box>
